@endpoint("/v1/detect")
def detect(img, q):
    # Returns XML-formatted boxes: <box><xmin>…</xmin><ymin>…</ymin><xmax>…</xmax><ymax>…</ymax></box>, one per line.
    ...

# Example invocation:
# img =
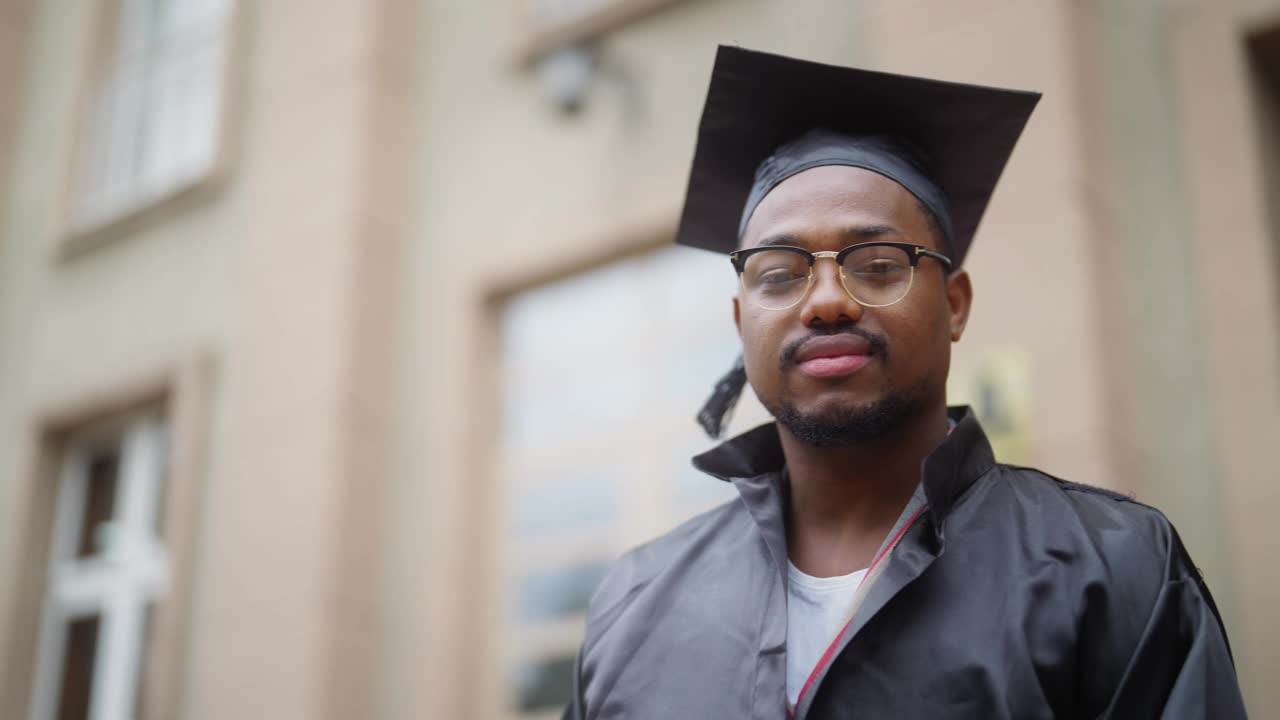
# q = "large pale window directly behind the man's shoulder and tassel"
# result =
<box><xmin>498</xmin><ymin>247</ymin><xmax>768</xmax><ymax>719</ymax></box>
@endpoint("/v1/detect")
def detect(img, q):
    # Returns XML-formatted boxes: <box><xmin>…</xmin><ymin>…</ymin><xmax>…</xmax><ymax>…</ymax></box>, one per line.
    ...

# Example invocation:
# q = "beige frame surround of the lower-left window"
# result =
<box><xmin>0</xmin><ymin>351</ymin><xmax>215</xmax><ymax>720</ymax></box>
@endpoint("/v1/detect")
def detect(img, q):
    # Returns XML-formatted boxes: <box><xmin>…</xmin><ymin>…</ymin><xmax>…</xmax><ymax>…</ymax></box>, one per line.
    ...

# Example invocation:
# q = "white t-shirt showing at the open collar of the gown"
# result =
<box><xmin>787</xmin><ymin>560</ymin><xmax>867</xmax><ymax>707</ymax></box>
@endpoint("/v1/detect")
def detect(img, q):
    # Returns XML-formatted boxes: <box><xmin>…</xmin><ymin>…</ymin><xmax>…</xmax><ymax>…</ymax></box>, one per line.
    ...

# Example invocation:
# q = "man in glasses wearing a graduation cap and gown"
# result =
<box><xmin>566</xmin><ymin>47</ymin><xmax>1244</xmax><ymax>720</ymax></box>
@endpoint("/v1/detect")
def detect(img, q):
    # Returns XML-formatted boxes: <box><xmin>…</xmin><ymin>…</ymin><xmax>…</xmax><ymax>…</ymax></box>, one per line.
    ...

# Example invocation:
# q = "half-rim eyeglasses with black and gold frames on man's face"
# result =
<box><xmin>728</xmin><ymin>242</ymin><xmax>951</xmax><ymax>310</ymax></box>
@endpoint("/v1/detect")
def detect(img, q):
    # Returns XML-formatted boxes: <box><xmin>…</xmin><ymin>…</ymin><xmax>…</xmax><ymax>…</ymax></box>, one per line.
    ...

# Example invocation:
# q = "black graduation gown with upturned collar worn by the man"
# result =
<box><xmin>564</xmin><ymin>409</ymin><xmax>1244</xmax><ymax>720</ymax></box>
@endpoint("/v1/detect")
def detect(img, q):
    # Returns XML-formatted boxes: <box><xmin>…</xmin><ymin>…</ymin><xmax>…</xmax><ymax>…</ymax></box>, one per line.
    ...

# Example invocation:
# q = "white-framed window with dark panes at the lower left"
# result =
<box><xmin>31</xmin><ymin>415</ymin><xmax>169</xmax><ymax>720</ymax></box>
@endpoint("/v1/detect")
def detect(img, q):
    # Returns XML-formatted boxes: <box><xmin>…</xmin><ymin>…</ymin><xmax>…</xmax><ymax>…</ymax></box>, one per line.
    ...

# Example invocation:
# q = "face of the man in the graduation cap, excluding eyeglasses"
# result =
<box><xmin>733</xmin><ymin>165</ymin><xmax>972</xmax><ymax>446</ymax></box>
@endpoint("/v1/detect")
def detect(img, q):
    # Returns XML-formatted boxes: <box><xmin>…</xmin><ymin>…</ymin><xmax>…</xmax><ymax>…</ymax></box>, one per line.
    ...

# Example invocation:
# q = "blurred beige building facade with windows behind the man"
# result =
<box><xmin>0</xmin><ymin>0</ymin><xmax>1280</xmax><ymax>720</ymax></box>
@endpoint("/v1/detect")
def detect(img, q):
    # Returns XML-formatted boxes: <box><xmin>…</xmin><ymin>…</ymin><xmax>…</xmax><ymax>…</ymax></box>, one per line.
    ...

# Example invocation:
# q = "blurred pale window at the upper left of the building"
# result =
<box><xmin>70</xmin><ymin>0</ymin><xmax>232</xmax><ymax>232</ymax></box>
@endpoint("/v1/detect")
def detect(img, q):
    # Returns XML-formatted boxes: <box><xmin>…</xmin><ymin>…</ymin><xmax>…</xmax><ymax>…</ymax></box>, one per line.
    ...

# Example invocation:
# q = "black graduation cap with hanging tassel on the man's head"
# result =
<box><xmin>676</xmin><ymin>45</ymin><xmax>1041</xmax><ymax>437</ymax></box>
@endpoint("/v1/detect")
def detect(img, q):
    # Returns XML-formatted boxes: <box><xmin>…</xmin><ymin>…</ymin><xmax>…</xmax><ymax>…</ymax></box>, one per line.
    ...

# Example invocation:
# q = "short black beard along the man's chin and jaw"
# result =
<box><xmin>769</xmin><ymin>388</ymin><xmax>925</xmax><ymax>447</ymax></box>
